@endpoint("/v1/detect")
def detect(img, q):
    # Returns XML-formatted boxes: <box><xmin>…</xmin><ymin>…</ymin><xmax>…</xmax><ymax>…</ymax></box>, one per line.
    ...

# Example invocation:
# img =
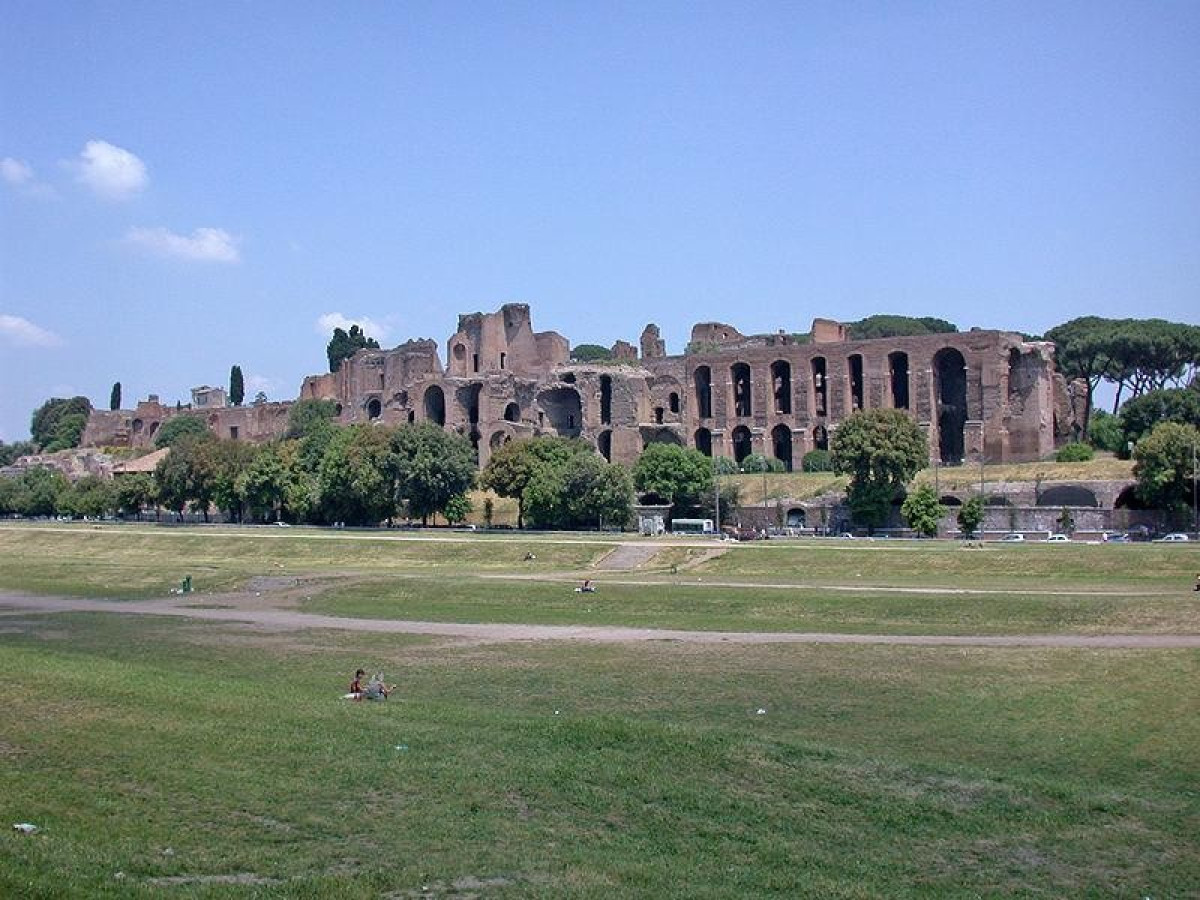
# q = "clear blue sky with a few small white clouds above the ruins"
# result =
<box><xmin>0</xmin><ymin>0</ymin><xmax>1200</xmax><ymax>440</ymax></box>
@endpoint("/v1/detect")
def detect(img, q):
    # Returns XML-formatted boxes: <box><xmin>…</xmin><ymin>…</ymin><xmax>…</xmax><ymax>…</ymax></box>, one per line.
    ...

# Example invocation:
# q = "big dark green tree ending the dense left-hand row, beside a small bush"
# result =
<box><xmin>391</xmin><ymin>422</ymin><xmax>476</xmax><ymax>523</ymax></box>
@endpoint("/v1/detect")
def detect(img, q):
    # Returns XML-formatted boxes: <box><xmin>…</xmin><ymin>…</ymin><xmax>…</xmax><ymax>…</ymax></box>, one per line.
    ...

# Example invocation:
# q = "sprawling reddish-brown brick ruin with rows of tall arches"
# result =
<box><xmin>84</xmin><ymin>304</ymin><xmax>1074</xmax><ymax>470</ymax></box>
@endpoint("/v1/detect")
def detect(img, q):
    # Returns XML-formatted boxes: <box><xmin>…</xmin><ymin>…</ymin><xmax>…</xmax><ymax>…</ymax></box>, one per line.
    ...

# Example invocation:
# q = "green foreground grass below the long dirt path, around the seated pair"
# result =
<box><xmin>0</xmin><ymin>616</ymin><xmax>1200</xmax><ymax>898</ymax></box>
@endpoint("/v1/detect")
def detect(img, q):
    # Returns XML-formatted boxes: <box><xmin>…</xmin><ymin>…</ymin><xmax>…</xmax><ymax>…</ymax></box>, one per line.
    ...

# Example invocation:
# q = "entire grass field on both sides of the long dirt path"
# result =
<box><xmin>0</xmin><ymin>528</ymin><xmax>1200</xmax><ymax>898</ymax></box>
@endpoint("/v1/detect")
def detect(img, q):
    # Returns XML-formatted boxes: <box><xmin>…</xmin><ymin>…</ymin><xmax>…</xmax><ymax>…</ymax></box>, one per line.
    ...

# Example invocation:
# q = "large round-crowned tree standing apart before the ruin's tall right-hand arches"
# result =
<box><xmin>830</xmin><ymin>409</ymin><xmax>929</xmax><ymax>532</ymax></box>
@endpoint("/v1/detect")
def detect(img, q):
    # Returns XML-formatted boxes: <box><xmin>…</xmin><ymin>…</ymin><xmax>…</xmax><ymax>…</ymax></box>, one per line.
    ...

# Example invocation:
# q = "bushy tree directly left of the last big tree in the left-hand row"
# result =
<box><xmin>318</xmin><ymin>425</ymin><xmax>396</xmax><ymax>524</ymax></box>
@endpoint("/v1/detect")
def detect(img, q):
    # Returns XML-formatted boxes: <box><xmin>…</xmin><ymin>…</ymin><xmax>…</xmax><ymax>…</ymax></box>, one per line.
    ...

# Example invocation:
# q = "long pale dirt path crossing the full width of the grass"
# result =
<box><xmin>0</xmin><ymin>592</ymin><xmax>1200</xmax><ymax>649</ymax></box>
